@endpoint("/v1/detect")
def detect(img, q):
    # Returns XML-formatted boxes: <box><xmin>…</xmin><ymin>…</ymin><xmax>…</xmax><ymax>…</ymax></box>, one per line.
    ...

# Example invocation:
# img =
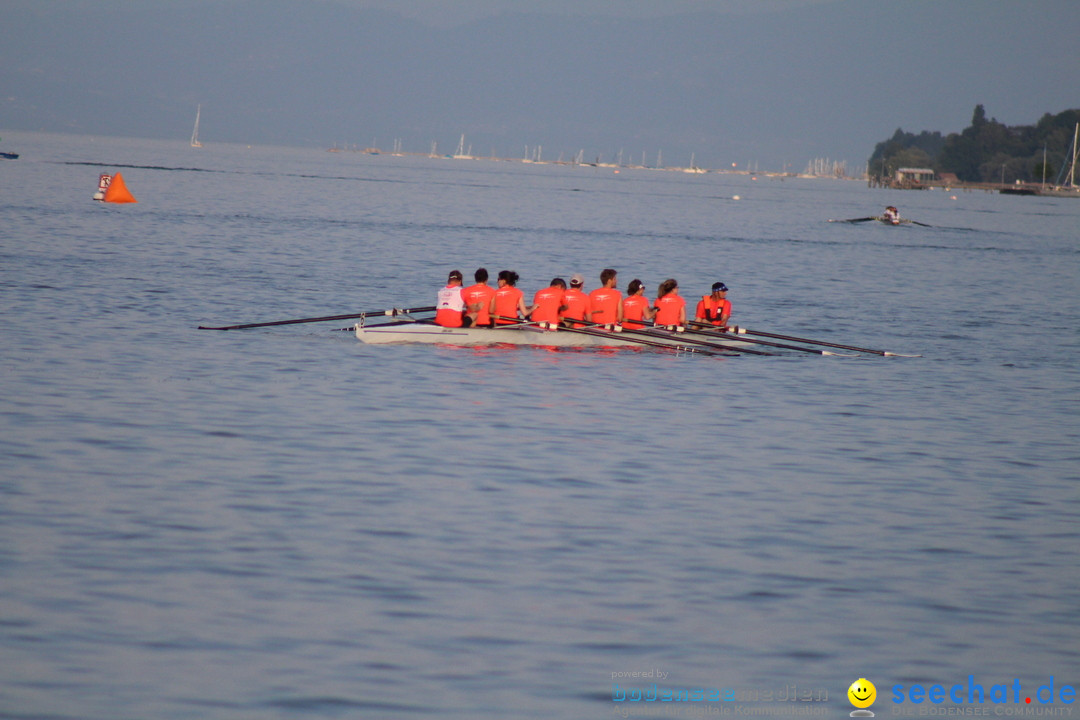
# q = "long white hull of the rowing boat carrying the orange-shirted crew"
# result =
<box><xmin>355</xmin><ymin>322</ymin><xmax>750</xmax><ymax>349</ymax></box>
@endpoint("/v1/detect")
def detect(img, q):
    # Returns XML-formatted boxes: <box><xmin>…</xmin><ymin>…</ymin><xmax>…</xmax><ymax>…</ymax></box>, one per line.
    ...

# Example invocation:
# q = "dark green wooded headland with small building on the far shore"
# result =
<box><xmin>867</xmin><ymin>105</ymin><xmax>1080</xmax><ymax>184</ymax></box>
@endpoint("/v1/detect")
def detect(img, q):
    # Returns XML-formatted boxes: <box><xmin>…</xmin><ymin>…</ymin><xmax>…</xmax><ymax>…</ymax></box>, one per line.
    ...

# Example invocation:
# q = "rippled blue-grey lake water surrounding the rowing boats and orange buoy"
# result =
<box><xmin>0</xmin><ymin>132</ymin><xmax>1080</xmax><ymax>720</ymax></box>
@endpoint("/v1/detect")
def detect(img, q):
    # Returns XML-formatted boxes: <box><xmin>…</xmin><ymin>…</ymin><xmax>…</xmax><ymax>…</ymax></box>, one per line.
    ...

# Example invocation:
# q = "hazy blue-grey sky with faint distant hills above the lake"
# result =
<box><xmin>0</xmin><ymin>0</ymin><xmax>1080</xmax><ymax>171</ymax></box>
